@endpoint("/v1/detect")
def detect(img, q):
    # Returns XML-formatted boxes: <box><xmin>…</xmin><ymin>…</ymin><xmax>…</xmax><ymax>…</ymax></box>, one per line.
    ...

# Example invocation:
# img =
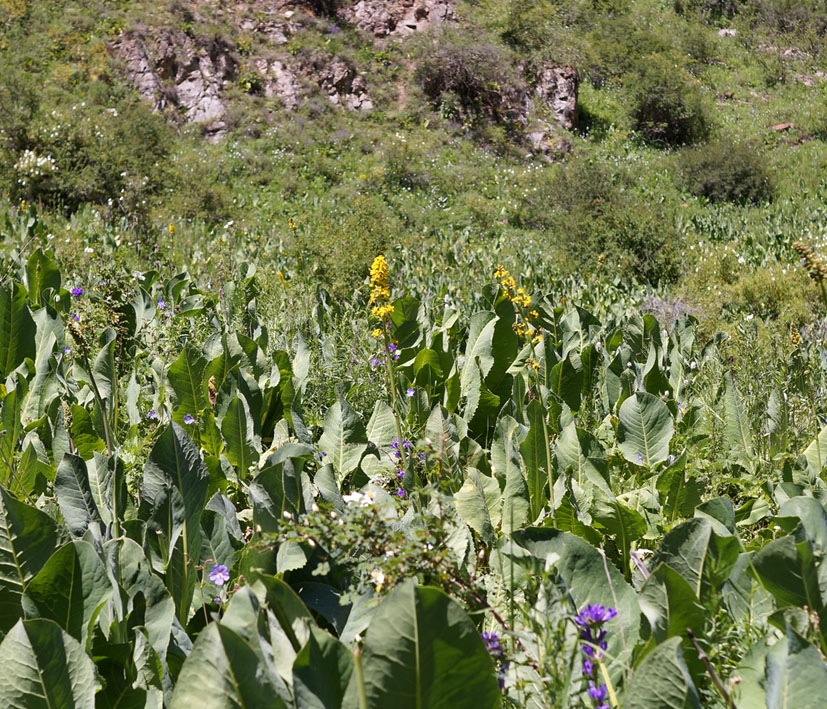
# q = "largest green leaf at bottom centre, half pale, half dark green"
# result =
<box><xmin>362</xmin><ymin>581</ymin><xmax>500</xmax><ymax>709</ymax></box>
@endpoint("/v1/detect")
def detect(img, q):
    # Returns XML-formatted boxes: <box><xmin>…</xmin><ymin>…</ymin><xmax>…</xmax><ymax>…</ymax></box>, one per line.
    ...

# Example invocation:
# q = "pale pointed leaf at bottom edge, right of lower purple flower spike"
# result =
<box><xmin>623</xmin><ymin>638</ymin><xmax>701</xmax><ymax>709</ymax></box>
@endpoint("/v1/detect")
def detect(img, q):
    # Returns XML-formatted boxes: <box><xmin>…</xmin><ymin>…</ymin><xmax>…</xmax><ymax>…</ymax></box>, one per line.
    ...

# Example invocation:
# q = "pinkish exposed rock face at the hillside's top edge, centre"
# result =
<box><xmin>339</xmin><ymin>0</ymin><xmax>454</xmax><ymax>37</ymax></box>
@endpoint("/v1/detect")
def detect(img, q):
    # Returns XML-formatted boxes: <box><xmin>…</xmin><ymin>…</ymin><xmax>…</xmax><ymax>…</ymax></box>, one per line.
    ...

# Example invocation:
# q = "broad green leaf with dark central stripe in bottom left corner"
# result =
<box><xmin>0</xmin><ymin>619</ymin><xmax>95</xmax><ymax>709</ymax></box>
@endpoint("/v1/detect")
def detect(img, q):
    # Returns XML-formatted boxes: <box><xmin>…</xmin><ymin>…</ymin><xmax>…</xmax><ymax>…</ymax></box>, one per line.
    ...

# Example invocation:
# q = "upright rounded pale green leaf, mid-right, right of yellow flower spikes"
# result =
<box><xmin>617</xmin><ymin>391</ymin><xmax>675</xmax><ymax>468</ymax></box>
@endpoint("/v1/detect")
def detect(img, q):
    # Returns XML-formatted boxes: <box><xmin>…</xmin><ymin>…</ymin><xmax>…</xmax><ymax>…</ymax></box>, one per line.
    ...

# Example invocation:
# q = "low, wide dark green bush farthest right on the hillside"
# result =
<box><xmin>680</xmin><ymin>142</ymin><xmax>775</xmax><ymax>204</ymax></box>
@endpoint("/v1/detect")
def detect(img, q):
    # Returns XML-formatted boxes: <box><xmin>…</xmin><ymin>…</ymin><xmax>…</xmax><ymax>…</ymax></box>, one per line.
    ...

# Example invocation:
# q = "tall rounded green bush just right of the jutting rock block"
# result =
<box><xmin>626</xmin><ymin>55</ymin><xmax>710</xmax><ymax>146</ymax></box>
